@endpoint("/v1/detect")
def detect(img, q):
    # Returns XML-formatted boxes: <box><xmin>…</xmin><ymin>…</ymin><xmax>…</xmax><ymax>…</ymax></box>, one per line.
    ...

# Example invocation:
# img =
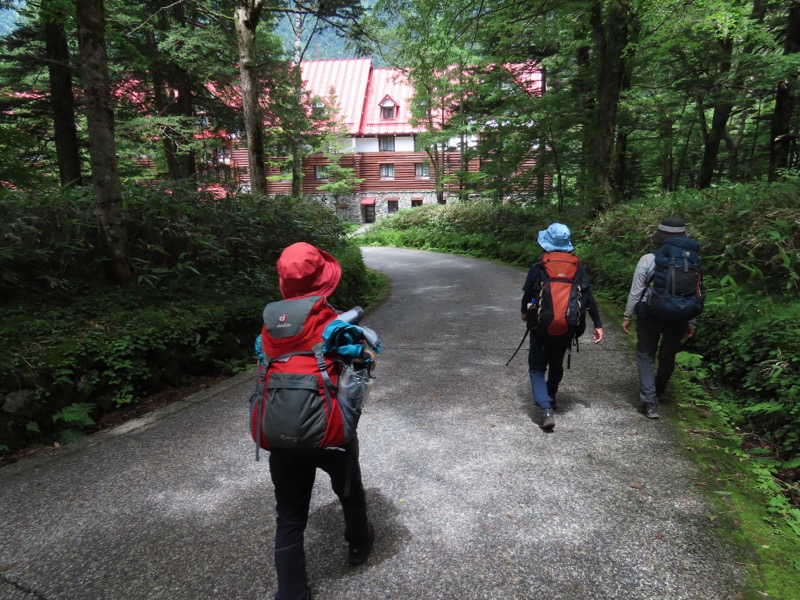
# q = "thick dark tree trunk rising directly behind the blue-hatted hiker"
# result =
<box><xmin>591</xmin><ymin>0</ymin><xmax>628</xmax><ymax>212</ymax></box>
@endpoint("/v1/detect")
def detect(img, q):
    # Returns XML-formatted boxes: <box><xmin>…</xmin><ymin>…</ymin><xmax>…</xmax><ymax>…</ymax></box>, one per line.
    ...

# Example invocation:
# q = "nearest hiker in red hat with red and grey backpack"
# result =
<box><xmin>255</xmin><ymin>242</ymin><xmax>380</xmax><ymax>600</ymax></box>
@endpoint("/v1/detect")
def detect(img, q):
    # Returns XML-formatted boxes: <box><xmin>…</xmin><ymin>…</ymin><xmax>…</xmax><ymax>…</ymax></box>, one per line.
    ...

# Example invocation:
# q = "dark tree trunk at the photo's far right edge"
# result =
<box><xmin>769</xmin><ymin>4</ymin><xmax>800</xmax><ymax>181</ymax></box>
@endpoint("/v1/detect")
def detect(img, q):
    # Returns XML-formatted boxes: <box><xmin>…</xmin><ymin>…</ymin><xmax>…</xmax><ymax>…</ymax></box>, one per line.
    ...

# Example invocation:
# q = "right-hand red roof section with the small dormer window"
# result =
<box><xmin>359</xmin><ymin>69</ymin><xmax>419</xmax><ymax>135</ymax></box>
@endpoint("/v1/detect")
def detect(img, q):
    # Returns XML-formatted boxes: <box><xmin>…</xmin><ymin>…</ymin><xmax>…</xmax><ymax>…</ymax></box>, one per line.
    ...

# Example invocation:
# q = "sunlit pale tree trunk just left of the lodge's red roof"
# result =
<box><xmin>234</xmin><ymin>0</ymin><xmax>267</xmax><ymax>196</ymax></box>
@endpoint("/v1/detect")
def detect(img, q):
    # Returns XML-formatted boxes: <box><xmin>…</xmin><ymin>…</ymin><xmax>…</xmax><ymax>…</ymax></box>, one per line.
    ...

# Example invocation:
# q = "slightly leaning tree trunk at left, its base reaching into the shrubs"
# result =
<box><xmin>75</xmin><ymin>0</ymin><xmax>131</xmax><ymax>281</ymax></box>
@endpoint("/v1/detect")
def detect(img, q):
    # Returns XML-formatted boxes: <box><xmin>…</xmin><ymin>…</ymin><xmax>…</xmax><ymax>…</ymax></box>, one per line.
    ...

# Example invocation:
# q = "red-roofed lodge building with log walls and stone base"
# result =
<box><xmin>223</xmin><ymin>58</ymin><xmax>540</xmax><ymax>223</ymax></box>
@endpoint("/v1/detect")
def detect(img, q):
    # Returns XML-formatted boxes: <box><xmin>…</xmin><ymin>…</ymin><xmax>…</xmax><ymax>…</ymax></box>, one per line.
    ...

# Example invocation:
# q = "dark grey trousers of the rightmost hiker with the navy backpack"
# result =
<box><xmin>636</xmin><ymin>317</ymin><xmax>689</xmax><ymax>404</ymax></box>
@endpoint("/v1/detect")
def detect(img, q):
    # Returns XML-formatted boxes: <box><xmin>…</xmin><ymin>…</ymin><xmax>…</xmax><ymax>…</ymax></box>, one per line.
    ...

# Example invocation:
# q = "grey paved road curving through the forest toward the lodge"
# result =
<box><xmin>0</xmin><ymin>248</ymin><xmax>744</xmax><ymax>600</ymax></box>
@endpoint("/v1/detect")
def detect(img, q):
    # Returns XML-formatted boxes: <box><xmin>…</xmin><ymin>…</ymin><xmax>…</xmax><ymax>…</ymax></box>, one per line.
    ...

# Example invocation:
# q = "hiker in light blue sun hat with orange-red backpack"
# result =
<box><xmin>521</xmin><ymin>223</ymin><xmax>603</xmax><ymax>431</ymax></box>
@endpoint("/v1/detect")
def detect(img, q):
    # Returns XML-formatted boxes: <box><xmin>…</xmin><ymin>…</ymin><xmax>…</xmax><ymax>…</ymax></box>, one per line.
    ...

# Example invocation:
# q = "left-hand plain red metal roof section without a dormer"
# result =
<box><xmin>300</xmin><ymin>58</ymin><xmax>372</xmax><ymax>135</ymax></box>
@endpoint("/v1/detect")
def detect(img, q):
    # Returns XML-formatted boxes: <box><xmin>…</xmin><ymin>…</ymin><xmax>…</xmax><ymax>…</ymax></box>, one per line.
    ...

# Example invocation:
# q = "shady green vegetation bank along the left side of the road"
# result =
<box><xmin>0</xmin><ymin>186</ymin><xmax>379</xmax><ymax>464</ymax></box>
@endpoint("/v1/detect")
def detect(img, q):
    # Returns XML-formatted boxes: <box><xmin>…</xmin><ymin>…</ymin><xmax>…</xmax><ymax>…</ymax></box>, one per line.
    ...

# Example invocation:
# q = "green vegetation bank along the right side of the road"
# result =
<box><xmin>361</xmin><ymin>181</ymin><xmax>800</xmax><ymax>598</ymax></box>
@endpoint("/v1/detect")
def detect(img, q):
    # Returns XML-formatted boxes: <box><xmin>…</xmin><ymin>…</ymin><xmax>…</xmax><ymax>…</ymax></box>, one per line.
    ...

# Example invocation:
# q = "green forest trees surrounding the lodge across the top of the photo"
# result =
<box><xmin>0</xmin><ymin>0</ymin><xmax>800</xmax><ymax>212</ymax></box>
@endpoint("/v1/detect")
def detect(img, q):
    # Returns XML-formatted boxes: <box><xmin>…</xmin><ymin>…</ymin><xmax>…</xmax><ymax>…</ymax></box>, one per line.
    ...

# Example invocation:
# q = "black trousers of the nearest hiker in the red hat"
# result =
<box><xmin>269</xmin><ymin>439</ymin><xmax>367</xmax><ymax>600</ymax></box>
